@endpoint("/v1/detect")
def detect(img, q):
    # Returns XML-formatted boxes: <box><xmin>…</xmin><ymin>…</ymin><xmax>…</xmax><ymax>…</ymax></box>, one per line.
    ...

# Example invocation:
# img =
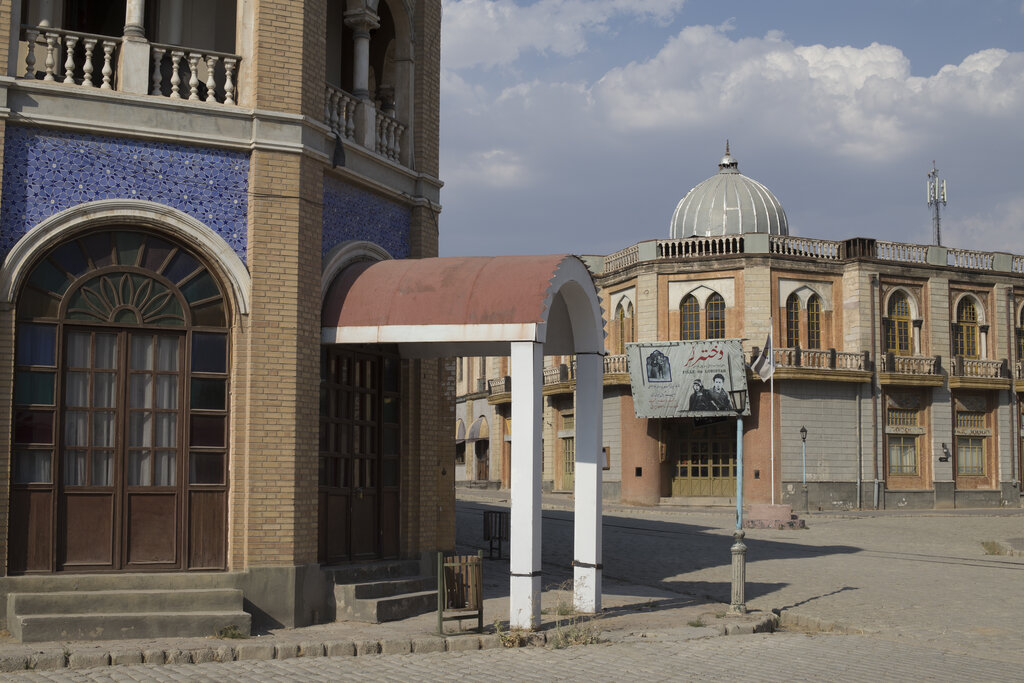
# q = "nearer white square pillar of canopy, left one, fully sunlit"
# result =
<box><xmin>509</xmin><ymin>342</ymin><xmax>544</xmax><ymax>629</ymax></box>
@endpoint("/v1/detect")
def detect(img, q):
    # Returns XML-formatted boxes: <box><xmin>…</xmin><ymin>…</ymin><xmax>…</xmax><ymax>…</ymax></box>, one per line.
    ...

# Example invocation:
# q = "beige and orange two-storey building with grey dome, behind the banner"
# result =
<box><xmin>457</xmin><ymin>150</ymin><xmax>1024</xmax><ymax>510</ymax></box>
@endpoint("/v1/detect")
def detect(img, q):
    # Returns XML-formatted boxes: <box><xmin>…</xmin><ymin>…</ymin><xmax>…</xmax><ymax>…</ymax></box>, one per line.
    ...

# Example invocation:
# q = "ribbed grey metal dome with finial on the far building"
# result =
<box><xmin>669</xmin><ymin>142</ymin><xmax>790</xmax><ymax>238</ymax></box>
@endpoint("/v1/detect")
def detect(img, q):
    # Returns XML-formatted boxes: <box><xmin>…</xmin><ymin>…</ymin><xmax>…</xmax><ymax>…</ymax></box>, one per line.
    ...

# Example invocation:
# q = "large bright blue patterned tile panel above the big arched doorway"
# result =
<box><xmin>0</xmin><ymin>126</ymin><xmax>249</xmax><ymax>261</ymax></box>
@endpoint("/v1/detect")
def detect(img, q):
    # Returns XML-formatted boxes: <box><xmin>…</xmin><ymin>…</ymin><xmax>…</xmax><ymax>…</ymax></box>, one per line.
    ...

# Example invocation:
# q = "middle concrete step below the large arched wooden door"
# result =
<box><xmin>7</xmin><ymin>588</ymin><xmax>242</xmax><ymax>616</ymax></box>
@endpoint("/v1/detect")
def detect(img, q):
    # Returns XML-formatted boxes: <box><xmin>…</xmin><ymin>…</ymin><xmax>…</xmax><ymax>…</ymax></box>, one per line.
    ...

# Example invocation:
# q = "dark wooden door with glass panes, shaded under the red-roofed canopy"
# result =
<box><xmin>318</xmin><ymin>346</ymin><xmax>401</xmax><ymax>564</ymax></box>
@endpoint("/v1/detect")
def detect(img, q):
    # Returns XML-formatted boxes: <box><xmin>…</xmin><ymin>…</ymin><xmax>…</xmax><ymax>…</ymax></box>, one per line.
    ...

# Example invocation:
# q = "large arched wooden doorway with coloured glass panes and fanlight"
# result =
<box><xmin>9</xmin><ymin>225</ymin><xmax>230</xmax><ymax>573</ymax></box>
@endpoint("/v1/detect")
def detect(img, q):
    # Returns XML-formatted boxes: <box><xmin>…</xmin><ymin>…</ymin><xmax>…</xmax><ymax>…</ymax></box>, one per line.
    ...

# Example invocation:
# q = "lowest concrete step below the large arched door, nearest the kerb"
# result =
<box><xmin>7</xmin><ymin>609</ymin><xmax>252</xmax><ymax>643</ymax></box>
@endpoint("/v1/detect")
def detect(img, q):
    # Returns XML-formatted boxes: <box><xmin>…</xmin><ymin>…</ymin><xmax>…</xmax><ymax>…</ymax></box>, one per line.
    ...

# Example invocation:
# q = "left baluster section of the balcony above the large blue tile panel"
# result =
<box><xmin>22</xmin><ymin>26</ymin><xmax>121</xmax><ymax>90</ymax></box>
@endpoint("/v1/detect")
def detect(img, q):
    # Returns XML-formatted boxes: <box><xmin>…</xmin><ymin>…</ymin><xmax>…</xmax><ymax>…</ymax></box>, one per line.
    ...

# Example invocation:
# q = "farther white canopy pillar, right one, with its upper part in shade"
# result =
<box><xmin>572</xmin><ymin>353</ymin><xmax>604</xmax><ymax>613</ymax></box>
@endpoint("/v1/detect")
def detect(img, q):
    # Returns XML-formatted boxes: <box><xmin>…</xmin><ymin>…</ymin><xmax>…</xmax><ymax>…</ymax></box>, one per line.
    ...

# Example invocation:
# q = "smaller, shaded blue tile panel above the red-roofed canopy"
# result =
<box><xmin>323</xmin><ymin>176</ymin><xmax>413</xmax><ymax>258</ymax></box>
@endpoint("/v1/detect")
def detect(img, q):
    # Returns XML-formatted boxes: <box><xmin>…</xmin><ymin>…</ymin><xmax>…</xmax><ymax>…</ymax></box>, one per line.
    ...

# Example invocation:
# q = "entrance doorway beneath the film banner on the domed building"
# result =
<box><xmin>669</xmin><ymin>420</ymin><xmax>736</xmax><ymax>498</ymax></box>
